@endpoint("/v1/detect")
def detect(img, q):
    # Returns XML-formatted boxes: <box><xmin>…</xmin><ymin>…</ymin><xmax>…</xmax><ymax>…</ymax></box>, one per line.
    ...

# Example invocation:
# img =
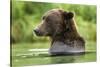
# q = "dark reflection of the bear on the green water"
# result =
<box><xmin>51</xmin><ymin>53</ymin><xmax>85</xmax><ymax>64</ymax></box>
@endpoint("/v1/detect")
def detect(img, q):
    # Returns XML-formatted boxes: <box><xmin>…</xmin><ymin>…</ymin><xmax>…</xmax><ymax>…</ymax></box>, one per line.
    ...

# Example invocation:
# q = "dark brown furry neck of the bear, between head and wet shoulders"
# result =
<box><xmin>51</xmin><ymin>20</ymin><xmax>80</xmax><ymax>43</ymax></box>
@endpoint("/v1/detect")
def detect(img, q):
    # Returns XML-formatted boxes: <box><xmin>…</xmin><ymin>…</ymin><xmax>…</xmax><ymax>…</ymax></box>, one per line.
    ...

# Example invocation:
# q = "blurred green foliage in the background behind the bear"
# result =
<box><xmin>11</xmin><ymin>0</ymin><xmax>96</xmax><ymax>43</ymax></box>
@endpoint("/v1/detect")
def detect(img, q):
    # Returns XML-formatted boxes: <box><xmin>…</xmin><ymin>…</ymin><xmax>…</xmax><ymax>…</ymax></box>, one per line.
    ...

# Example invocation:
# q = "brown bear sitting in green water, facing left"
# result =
<box><xmin>34</xmin><ymin>9</ymin><xmax>85</xmax><ymax>55</ymax></box>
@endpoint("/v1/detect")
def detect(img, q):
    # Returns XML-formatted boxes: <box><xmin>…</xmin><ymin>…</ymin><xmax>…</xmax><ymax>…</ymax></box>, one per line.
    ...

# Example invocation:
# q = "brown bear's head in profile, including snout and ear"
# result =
<box><xmin>34</xmin><ymin>9</ymin><xmax>74</xmax><ymax>36</ymax></box>
